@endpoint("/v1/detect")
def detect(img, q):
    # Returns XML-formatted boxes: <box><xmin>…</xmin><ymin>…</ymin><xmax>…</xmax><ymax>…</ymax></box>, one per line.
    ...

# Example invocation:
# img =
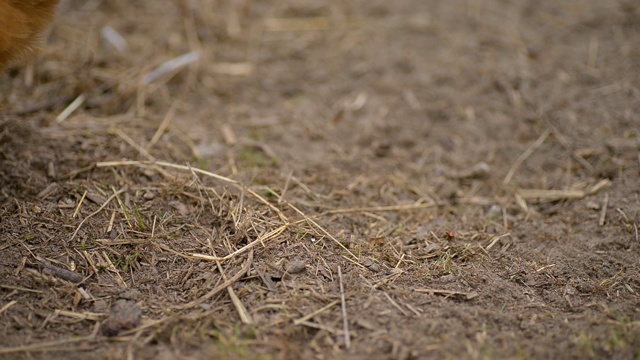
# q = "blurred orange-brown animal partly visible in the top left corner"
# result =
<box><xmin>0</xmin><ymin>0</ymin><xmax>59</xmax><ymax>71</ymax></box>
